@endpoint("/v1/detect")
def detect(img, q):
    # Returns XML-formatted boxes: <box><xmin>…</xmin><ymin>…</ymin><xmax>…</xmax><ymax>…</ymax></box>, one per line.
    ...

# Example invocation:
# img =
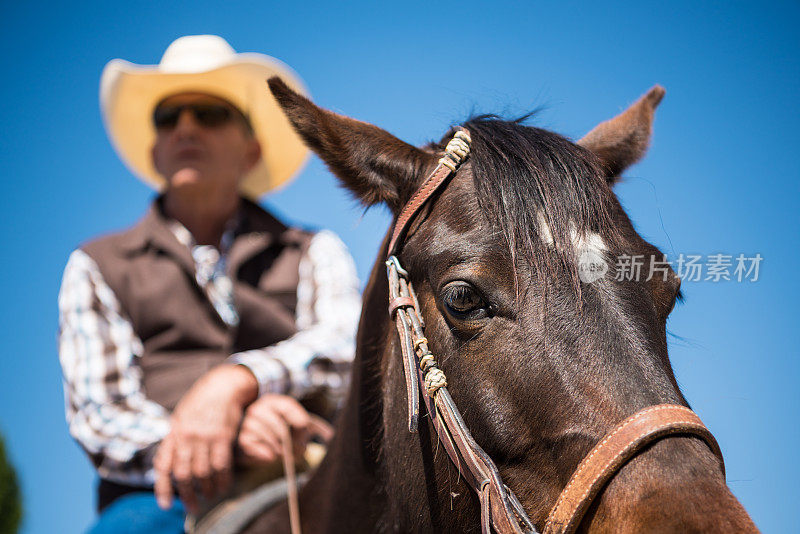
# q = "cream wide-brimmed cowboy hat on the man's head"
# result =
<box><xmin>100</xmin><ymin>35</ymin><xmax>308</xmax><ymax>198</ymax></box>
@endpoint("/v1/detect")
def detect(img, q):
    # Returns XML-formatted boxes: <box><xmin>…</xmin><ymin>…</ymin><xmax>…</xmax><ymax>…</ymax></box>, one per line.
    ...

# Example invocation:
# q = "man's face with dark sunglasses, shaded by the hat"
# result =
<box><xmin>152</xmin><ymin>93</ymin><xmax>261</xmax><ymax>195</ymax></box>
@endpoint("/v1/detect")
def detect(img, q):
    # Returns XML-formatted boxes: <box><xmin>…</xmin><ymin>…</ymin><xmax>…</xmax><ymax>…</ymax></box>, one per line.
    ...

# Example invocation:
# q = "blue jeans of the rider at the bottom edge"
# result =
<box><xmin>89</xmin><ymin>492</ymin><xmax>186</xmax><ymax>534</ymax></box>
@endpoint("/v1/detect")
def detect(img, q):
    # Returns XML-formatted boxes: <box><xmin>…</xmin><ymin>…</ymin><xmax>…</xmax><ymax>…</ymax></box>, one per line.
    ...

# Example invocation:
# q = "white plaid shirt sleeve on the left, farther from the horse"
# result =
<box><xmin>58</xmin><ymin>250</ymin><xmax>169</xmax><ymax>486</ymax></box>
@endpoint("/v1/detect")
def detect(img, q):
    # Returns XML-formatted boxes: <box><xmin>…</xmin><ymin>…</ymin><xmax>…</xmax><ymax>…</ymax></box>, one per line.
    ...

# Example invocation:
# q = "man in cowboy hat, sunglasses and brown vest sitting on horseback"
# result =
<box><xmin>59</xmin><ymin>35</ymin><xmax>360</xmax><ymax>532</ymax></box>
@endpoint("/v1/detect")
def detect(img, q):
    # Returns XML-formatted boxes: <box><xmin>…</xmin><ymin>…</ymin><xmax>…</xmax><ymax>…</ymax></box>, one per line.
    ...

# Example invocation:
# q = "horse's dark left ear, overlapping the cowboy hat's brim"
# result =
<box><xmin>267</xmin><ymin>76</ymin><xmax>435</xmax><ymax>212</ymax></box>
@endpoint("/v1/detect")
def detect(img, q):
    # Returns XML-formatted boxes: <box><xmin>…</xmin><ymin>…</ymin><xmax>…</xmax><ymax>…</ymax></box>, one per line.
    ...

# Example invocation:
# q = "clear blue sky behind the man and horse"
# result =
<box><xmin>0</xmin><ymin>1</ymin><xmax>800</xmax><ymax>533</ymax></box>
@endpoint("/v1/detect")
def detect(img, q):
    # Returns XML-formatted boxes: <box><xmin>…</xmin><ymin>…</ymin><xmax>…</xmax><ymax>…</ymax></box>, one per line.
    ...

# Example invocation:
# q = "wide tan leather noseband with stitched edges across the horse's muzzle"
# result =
<box><xmin>544</xmin><ymin>404</ymin><xmax>725</xmax><ymax>534</ymax></box>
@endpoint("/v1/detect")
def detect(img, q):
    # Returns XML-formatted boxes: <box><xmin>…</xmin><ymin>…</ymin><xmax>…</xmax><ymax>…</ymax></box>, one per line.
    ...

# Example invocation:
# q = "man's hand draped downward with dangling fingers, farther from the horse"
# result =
<box><xmin>153</xmin><ymin>364</ymin><xmax>258</xmax><ymax>512</ymax></box>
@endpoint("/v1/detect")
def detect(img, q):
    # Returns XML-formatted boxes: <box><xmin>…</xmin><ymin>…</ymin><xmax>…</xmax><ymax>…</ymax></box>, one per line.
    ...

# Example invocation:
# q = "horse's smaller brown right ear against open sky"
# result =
<box><xmin>578</xmin><ymin>85</ymin><xmax>666</xmax><ymax>184</ymax></box>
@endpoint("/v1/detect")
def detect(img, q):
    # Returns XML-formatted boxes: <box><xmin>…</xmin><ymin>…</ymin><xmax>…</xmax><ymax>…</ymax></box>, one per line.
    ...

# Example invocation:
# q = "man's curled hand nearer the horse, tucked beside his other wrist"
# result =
<box><xmin>237</xmin><ymin>395</ymin><xmax>311</xmax><ymax>465</ymax></box>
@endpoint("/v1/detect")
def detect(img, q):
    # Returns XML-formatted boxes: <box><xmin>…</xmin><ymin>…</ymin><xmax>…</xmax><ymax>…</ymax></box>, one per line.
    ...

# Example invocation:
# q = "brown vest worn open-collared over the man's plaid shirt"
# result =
<box><xmin>81</xmin><ymin>200</ymin><xmax>311</xmax><ymax>411</ymax></box>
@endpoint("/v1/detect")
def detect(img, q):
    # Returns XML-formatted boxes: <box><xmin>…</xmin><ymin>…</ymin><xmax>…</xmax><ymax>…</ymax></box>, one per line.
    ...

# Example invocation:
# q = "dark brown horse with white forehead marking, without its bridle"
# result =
<box><xmin>242</xmin><ymin>78</ymin><xmax>756</xmax><ymax>533</ymax></box>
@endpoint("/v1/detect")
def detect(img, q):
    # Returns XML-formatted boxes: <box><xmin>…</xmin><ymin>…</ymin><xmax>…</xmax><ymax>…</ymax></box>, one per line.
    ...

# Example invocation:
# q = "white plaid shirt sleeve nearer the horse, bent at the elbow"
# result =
<box><xmin>229</xmin><ymin>231</ymin><xmax>361</xmax><ymax>399</ymax></box>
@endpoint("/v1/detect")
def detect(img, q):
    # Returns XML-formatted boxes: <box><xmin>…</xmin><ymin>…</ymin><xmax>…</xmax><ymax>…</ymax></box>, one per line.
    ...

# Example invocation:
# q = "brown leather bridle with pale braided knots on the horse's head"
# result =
<box><xmin>386</xmin><ymin>128</ymin><xmax>725</xmax><ymax>534</ymax></box>
